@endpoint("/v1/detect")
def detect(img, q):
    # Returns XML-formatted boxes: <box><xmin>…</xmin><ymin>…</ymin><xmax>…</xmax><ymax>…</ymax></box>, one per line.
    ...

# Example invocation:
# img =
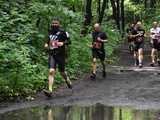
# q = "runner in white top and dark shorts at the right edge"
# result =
<box><xmin>150</xmin><ymin>21</ymin><xmax>160</xmax><ymax>67</ymax></box>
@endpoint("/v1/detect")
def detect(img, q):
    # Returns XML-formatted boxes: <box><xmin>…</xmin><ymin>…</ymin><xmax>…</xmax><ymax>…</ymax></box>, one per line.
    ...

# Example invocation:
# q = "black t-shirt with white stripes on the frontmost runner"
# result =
<box><xmin>48</xmin><ymin>29</ymin><xmax>70</xmax><ymax>53</ymax></box>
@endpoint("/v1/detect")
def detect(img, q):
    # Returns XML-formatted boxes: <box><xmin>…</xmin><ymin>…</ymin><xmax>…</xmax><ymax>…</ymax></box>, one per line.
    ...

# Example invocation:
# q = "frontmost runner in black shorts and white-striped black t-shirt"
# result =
<box><xmin>44</xmin><ymin>19</ymin><xmax>72</xmax><ymax>97</ymax></box>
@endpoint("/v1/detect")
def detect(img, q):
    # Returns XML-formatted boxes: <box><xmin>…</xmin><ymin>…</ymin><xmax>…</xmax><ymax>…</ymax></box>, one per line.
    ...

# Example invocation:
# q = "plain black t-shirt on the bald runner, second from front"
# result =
<box><xmin>92</xmin><ymin>32</ymin><xmax>107</xmax><ymax>50</ymax></box>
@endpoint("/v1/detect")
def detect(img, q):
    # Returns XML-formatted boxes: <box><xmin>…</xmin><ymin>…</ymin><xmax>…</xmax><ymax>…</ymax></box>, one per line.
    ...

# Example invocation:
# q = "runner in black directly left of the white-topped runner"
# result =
<box><xmin>132</xmin><ymin>21</ymin><xmax>145</xmax><ymax>68</ymax></box>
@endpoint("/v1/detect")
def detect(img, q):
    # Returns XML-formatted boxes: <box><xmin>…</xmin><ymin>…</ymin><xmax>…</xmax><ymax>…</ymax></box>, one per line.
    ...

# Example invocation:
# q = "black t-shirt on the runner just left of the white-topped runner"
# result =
<box><xmin>133</xmin><ymin>28</ymin><xmax>145</xmax><ymax>43</ymax></box>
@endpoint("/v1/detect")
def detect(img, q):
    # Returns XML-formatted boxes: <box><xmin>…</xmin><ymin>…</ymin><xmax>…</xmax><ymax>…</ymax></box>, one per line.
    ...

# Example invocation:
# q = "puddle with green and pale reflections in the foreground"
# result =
<box><xmin>0</xmin><ymin>105</ymin><xmax>160</xmax><ymax>120</ymax></box>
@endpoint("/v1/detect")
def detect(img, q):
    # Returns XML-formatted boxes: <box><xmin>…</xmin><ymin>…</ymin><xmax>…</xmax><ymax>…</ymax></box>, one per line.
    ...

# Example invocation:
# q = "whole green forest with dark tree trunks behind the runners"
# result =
<box><xmin>0</xmin><ymin>0</ymin><xmax>160</xmax><ymax>100</ymax></box>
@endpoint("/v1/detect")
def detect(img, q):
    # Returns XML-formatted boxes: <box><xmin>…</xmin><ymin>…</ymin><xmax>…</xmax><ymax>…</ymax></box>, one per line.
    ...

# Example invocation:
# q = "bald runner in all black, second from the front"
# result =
<box><xmin>91</xmin><ymin>23</ymin><xmax>107</xmax><ymax>80</ymax></box>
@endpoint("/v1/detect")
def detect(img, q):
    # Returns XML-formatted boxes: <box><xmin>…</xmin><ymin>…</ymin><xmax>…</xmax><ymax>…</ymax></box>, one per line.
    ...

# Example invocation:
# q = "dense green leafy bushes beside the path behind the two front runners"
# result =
<box><xmin>0</xmin><ymin>0</ymin><xmax>119</xmax><ymax>99</ymax></box>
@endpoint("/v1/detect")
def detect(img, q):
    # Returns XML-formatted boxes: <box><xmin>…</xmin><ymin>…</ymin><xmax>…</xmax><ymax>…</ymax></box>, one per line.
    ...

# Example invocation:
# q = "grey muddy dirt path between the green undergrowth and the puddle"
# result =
<box><xmin>0</xmin><ymin>43</ymin><xmax>160</xmax><ymax>113</ymax></box>
